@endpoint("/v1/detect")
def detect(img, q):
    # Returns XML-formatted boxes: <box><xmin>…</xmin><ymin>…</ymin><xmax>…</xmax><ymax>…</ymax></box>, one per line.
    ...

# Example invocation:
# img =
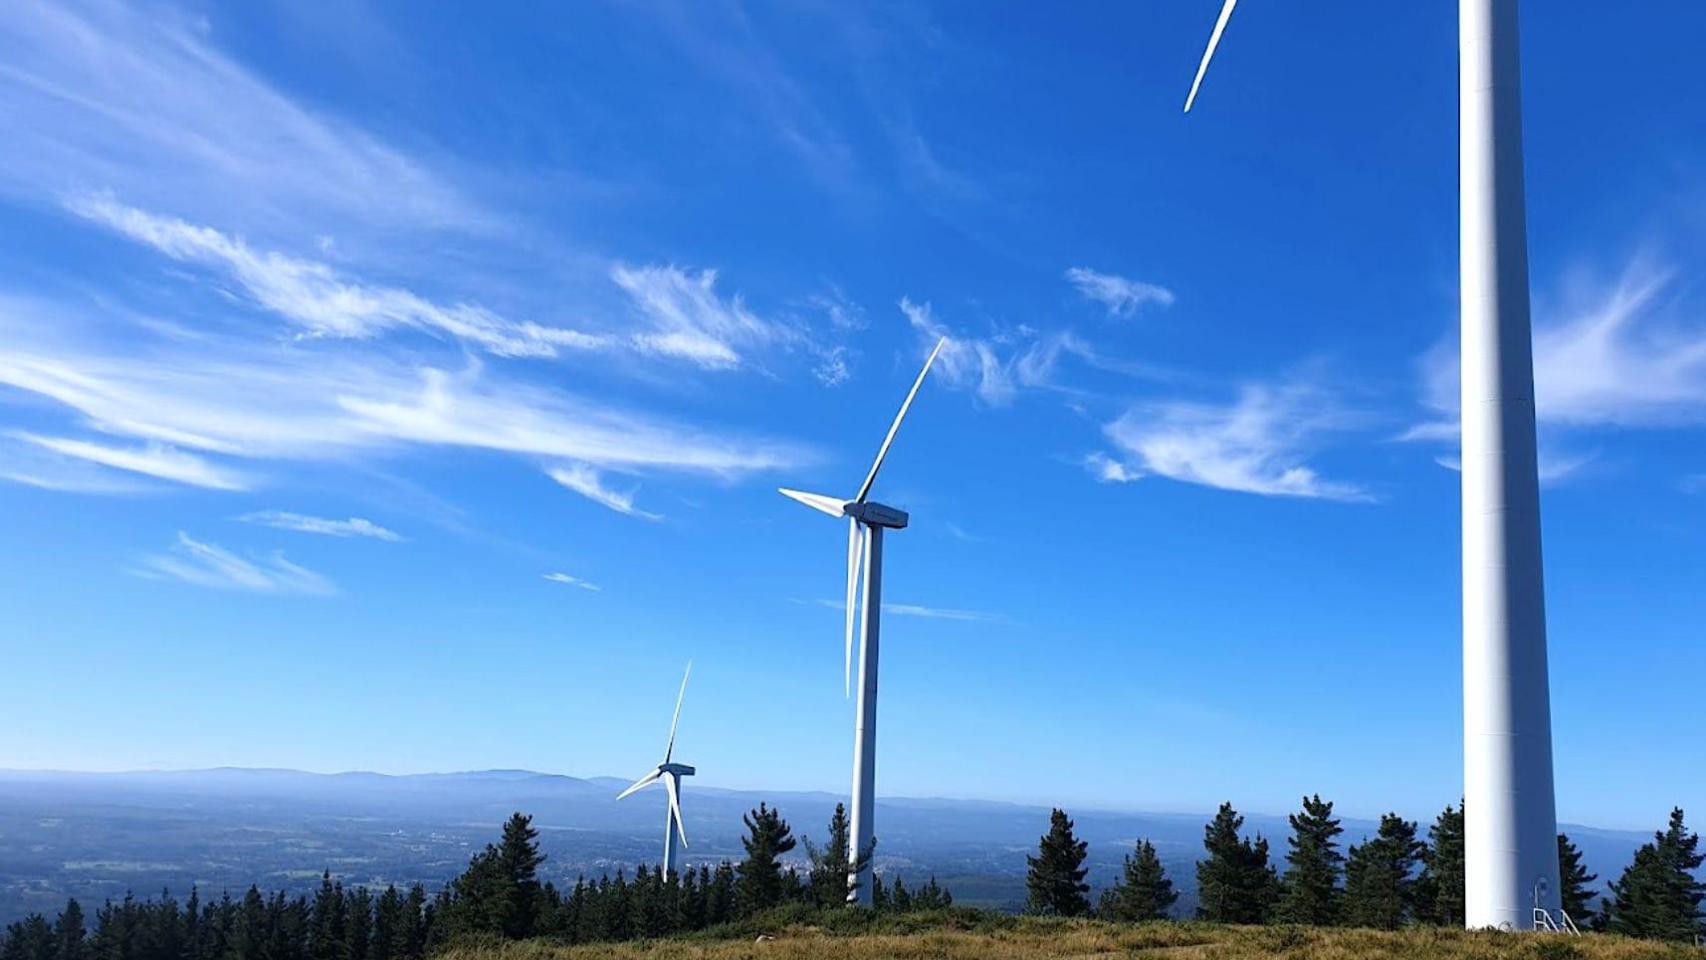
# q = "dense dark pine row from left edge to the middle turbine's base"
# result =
<box><xmin>0</xmin><ymin>803</ymin><xmax>954</xmax><ymax>960</ymax></box>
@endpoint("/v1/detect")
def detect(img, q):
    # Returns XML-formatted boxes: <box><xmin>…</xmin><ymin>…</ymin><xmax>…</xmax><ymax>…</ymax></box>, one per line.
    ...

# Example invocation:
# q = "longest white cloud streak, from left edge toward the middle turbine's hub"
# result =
<box><xmin>0</xmin><ymin>298</ymin><xmax>810</xmax><ymax>501</ymax></box>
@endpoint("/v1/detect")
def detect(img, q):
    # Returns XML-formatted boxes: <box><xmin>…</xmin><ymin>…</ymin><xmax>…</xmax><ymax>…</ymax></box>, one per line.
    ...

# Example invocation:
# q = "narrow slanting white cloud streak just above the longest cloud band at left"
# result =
<box><xmin>67</xmin><ymin>194</ymin><xmax>616</xmax><ymax>356</ymax></box>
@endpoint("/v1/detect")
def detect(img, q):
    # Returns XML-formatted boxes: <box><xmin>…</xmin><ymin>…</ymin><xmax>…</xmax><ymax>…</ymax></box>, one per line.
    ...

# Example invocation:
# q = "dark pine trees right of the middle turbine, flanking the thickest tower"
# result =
<box><xmin>1025</xmin><ymin>795</ymin><xmax>1706</xmax><ymax>941</ymax></box>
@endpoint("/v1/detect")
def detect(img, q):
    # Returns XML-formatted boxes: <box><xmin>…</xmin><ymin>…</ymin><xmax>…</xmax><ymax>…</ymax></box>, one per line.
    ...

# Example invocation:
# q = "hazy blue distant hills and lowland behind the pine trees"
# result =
<box><xmin>0</xmin><ymin>767</ymin><xmax>1650</xmax><ymax>922</ymax></box>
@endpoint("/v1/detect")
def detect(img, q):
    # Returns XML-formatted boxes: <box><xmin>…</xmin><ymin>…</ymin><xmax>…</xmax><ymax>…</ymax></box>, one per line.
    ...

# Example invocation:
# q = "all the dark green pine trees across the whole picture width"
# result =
<box><xmin>0</xmin><ymin>796</ymin><xmax>1706</xmax><ymax>960</ymax></box>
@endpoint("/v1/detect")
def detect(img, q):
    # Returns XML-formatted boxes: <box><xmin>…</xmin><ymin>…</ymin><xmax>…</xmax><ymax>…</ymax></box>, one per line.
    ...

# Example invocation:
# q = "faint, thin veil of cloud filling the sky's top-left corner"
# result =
<box><xmin>0</xmin><ymin>3</ymin><xmax>484</xmax><ymax>230</ymax></box>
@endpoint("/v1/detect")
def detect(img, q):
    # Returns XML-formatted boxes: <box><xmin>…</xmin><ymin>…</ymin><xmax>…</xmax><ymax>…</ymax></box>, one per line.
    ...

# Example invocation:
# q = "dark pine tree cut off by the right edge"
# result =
<box><xmin>1607</xmin><ymin>808</ymin><xmax>1706</xmax><ymax>941</ymax></box>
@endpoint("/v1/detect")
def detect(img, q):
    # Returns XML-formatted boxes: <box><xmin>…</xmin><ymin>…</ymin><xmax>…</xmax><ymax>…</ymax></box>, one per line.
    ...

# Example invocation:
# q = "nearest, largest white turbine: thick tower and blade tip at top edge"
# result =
<box><xmin>1184</xmin><ymin>0</ymin><xmax>1561</xmax><ymax>929</ymax></box>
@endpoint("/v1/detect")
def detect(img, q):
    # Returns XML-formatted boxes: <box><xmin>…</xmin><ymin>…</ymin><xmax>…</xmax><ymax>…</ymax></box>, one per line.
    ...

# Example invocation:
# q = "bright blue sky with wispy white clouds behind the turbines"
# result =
<box><xmin>0</xmin><ymin>0</ymin><xmax>1706</xmax><ymax>827</ymax></box>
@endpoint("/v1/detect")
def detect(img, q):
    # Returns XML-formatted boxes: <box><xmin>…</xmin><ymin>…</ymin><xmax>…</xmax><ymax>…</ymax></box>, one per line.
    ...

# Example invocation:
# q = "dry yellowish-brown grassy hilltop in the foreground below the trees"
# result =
<box><xmin>435</xmin><ymin>911</ymin><xmax>1706</xmax><ymax>960</ymax></box>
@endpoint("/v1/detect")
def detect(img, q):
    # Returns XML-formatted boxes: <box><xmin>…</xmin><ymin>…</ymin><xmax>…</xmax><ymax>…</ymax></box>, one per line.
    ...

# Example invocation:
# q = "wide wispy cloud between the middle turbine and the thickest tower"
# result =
<box><xmin>1085</xmin><ymin>382</ymin><xmax>1373</xmax><ymax>501</ymax></box>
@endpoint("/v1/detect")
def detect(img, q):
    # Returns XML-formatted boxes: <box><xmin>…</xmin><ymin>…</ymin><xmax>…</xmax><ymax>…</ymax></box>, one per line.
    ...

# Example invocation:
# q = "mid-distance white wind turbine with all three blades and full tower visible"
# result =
<box><xmin>781</xmin><ymin>338</ymin><xmax>949</xmax><ymax>905</ymax></box>
